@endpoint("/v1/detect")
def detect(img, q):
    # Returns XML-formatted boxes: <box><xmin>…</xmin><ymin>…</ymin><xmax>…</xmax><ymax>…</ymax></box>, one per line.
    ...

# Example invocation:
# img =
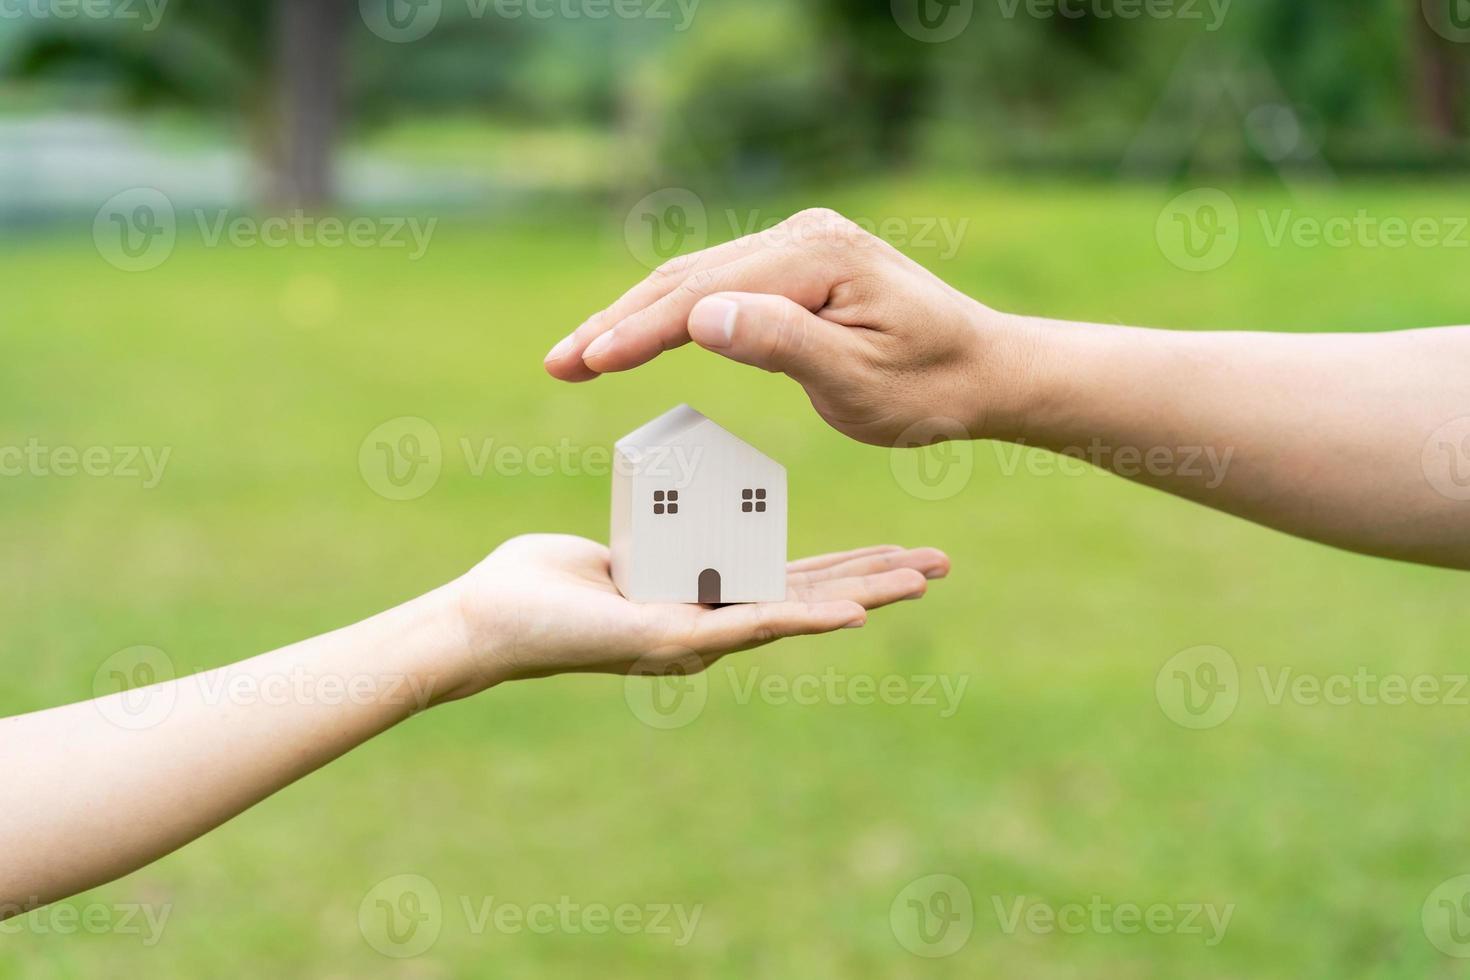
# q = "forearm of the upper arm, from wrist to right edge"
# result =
<box><xmin>1004</xmin><ymin>317</ymin><xmax>1470</xmax><ymax>567</ymax></box>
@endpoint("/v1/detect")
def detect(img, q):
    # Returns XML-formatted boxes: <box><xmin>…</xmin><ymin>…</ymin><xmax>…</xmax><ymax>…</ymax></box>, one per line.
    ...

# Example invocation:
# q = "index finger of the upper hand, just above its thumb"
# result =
<box><xmin>582</xmin><ymin>248</ymin><xmax>844</xmax><ymax>373</ymax></box>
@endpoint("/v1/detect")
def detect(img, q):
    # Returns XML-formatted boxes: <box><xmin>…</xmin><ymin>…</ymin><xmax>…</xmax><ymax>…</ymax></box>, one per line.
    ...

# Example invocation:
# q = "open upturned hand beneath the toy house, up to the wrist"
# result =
<box><xmin>456</xmin><ymin>535</ymin><xmax>950</xmax><ymax>696</ymax></box>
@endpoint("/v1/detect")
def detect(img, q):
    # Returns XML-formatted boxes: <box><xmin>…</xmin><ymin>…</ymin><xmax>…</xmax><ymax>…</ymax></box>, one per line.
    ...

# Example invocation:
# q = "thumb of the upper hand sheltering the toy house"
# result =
<box><xmin>689</xmin><ymin>292</ymin><xmax>850</xmax><ymax>381</ymax></box>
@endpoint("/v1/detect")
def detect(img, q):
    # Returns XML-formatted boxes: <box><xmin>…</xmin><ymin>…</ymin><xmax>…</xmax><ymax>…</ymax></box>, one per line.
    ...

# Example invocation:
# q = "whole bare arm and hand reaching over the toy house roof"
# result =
<box><xmin>545</xmin><ymin>209</ymin><xmax>1470</xmax><ymax>569</ymax></box>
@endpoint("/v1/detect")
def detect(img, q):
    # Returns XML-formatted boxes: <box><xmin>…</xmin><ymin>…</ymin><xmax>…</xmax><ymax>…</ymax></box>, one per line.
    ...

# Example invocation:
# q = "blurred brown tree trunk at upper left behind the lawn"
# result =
<box><xmin>272</xmin><ymin>0</ymin><xmax>356</xmax><ymax>210</ymax></box>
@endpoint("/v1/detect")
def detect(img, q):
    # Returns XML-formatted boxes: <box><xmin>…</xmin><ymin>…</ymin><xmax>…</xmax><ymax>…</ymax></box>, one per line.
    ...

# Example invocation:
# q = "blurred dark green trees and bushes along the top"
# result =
<box><xmin>0</xmin><ymin>0</ymin><xmax>1470</xmax><ymax>192</ymax></box>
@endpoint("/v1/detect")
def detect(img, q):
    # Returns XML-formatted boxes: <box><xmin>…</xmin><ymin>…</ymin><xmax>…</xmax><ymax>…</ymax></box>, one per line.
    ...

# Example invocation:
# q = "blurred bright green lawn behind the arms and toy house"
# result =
<box><xmin>0</xmin><ymin>181</ymin><xmax>1470</xmax><ymax>979</ymax></box>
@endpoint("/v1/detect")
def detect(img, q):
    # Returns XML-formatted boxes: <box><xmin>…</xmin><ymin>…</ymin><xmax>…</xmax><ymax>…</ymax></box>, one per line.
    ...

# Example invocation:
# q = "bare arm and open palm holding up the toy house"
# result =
<box><xmin>0</xmin><ymin>535</ymin><xmax>950</xmax><ymax>918</ymax></box>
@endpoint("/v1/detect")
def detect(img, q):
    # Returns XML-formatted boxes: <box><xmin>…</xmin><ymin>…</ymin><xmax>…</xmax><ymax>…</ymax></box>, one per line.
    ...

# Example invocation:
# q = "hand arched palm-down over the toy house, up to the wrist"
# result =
<box><xmin>545</xmin><ymin>209</ymin><xmax>1028</xmax><ymax>445</ymax></box>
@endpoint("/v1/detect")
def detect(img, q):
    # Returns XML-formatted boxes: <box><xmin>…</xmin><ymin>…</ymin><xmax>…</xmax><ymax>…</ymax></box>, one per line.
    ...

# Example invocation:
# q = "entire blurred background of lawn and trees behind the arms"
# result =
<box><xmin>0</xmin><ymin>0</ymin><xmax>1470</xmax><ymax>980</ymax></box>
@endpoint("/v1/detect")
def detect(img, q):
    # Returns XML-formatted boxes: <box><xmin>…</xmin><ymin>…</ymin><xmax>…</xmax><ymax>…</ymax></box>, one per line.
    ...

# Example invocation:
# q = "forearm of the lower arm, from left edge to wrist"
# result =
<box><xmin>0</xmin><ymin>589</ymin><xmax>467</xmax><ymax>917</ymax></box>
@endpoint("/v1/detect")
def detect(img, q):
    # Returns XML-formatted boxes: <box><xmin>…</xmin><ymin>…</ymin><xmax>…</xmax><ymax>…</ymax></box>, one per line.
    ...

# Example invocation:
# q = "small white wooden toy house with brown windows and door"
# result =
<box><xmin>612</xmin><ymin>406</ymin><xmax>786</xmax><ymax>602</ymax></box>
